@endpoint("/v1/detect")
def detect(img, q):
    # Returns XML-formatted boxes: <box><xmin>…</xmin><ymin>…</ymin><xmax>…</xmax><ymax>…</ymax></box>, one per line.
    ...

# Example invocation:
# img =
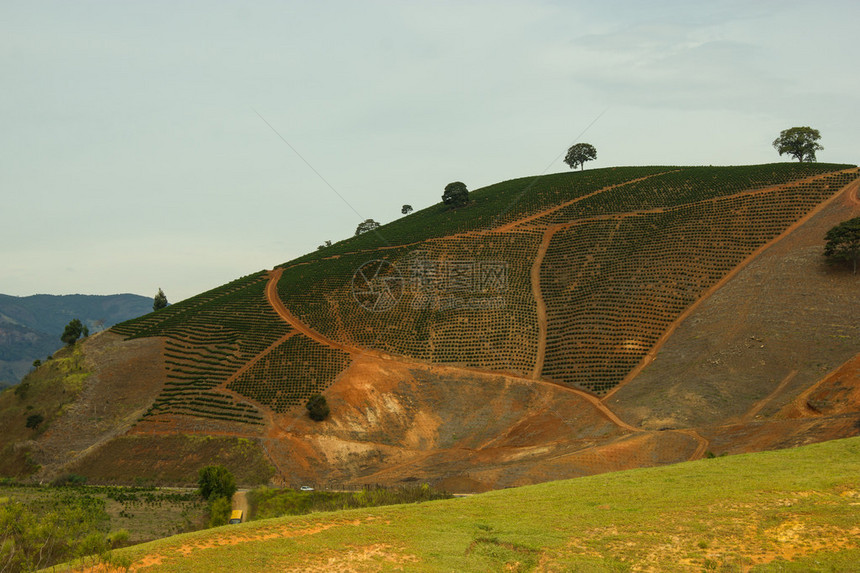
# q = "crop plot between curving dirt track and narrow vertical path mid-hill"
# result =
<box><xmin>279</xmin><ymin>232</ymin><xmax>541</xmax><ymax>374</ymax></box>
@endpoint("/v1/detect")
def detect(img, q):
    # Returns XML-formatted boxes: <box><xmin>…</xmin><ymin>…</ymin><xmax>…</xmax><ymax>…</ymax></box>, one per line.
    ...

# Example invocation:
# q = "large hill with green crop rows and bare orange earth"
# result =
<box><xmin>0</xmin><ymin>163</ymin><xmax>860</xmax><ymax>491</ymax></box>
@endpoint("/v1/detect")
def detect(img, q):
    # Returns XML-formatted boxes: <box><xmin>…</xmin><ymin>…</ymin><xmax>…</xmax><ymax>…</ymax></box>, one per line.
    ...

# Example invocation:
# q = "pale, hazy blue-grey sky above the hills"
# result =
<box><xmin>0</xmin><ymin>0</ymin><xmax>860</xmax><ymax>302</ymax></box>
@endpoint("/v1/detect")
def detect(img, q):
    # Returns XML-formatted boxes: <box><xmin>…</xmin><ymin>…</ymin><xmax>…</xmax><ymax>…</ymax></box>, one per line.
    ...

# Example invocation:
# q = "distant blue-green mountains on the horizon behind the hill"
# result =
<box><xmin>0</xmin><ymin>294</ymin><xmax>152</xmax><ymax>387</ymax></box>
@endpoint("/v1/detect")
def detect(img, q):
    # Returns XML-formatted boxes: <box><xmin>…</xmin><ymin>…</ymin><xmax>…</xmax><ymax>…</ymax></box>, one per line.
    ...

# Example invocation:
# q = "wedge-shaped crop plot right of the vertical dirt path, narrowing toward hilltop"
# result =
<box><xmin>541</xmin><ymin>168</ymin><xmax>852</xmax><ymax>394</ymax></box>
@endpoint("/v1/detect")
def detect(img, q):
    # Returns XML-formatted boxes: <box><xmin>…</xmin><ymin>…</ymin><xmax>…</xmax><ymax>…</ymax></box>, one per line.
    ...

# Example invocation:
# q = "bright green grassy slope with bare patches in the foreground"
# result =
<box><xmin>85</xmin><ymin>438</ymin><xmax>860</xmax><ymax>571</ymax></box>
